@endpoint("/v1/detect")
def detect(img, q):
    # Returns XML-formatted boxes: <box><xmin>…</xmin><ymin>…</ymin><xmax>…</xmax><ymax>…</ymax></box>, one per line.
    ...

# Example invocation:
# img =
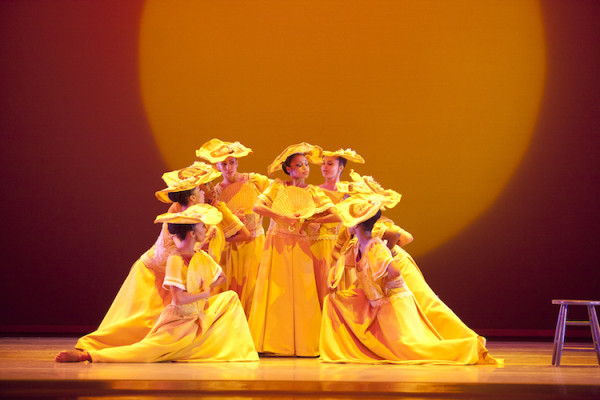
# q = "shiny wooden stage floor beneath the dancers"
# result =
<box><xmin>0</xmin><ymin>337</ymin><xmax>600</xmax><ymax>400</ymax></box>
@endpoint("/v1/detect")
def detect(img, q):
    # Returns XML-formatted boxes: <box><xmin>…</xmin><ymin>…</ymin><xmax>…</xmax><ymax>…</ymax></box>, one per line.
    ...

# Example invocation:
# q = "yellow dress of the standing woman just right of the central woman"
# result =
<box><xmin>308</xmin><ymin>189</ymin><xmax>344</xmax><ymax>306</ymax></box>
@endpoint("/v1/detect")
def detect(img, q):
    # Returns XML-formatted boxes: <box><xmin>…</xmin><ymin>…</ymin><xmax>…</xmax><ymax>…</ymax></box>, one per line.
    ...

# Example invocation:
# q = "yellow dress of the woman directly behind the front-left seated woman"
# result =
<box><xmin>75</xmin><ymin>203</ymin><xmax>243</xmax><ymax>350</ymax></box>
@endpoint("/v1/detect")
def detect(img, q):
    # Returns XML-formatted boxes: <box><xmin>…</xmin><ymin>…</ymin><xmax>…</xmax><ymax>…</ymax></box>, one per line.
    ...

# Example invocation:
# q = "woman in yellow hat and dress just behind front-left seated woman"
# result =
<box><xmin>75</xmin><ymin>162</ymin><xmax>243</xmax><ymax>350</ymax></box>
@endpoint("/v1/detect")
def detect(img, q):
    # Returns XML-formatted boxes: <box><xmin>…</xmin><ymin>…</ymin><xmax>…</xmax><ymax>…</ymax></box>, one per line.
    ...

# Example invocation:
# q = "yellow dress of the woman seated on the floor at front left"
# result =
<box><xmin>88</xmin><ymin>251</ymin><xmax>258</xmax><ymax>362</ymax></box>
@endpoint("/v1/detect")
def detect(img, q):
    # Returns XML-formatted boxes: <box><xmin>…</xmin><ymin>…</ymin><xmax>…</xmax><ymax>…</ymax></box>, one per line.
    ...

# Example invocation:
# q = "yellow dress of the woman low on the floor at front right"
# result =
<box><xmin>320</xmin><ymin>238</ymin><xmax>496</xmax><ymax>364</ymax></box>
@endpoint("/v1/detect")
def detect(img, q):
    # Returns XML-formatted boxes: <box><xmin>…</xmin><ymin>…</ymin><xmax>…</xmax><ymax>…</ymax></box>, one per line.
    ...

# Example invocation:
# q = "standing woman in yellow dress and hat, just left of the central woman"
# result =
<box><xmin>196</xmin><ymin>139</ymin><xmax>271</xmax><ymax>316</ymax></box>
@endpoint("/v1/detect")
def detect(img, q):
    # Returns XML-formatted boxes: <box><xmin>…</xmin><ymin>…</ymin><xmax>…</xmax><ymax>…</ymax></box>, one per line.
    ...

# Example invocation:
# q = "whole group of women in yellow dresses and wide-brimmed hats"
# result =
<box><xmin>56</xmin><ymin>139</ymin><xmax>498</xmax><ymax>364</ymax></box>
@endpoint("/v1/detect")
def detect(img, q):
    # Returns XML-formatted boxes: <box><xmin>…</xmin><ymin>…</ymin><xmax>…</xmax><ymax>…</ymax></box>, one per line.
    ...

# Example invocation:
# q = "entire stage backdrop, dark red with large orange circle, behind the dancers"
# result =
<box><xmin>0</xmin><ymin>0</ymin><xmax>600</xmax><ymax>336</ymax></box>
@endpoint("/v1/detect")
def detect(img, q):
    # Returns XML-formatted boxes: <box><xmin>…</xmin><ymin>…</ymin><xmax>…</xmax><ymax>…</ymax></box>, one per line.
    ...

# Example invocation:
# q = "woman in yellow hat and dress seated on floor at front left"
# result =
<box><xmin>56</xmin><ymin>204</ymin><xmax>258</xmax><ymax>362</ymax></box>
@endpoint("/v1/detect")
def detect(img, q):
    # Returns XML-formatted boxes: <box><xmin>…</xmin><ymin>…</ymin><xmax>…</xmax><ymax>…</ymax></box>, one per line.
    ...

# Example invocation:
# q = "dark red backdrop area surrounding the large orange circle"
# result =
<box><xmin>0</xmin><ymin>0</ymin><xmax>600</xmax><ymax>335</ymax></box>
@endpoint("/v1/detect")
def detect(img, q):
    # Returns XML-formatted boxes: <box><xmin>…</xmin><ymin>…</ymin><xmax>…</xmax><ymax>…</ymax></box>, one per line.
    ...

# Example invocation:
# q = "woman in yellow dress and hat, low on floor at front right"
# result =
<box><xmin>320</xmin><ymin>173</ymin><xmax>498</xmax><ymax>364</ymax></box>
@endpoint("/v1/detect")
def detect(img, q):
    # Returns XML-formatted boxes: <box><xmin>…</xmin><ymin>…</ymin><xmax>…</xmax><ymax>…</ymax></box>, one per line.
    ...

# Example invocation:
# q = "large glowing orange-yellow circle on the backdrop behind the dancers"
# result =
<box><xmin>140</xmin><ymin>0</ymin><xmax>545</xmax><ymax>255</ymax></box>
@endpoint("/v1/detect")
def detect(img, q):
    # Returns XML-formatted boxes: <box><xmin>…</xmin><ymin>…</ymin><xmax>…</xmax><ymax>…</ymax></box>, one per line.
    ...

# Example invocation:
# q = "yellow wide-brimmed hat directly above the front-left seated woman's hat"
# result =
<box><xmin>155</xmin><ymin>161</ymin><xmax>221</xmax><ymax>203</ymax></box>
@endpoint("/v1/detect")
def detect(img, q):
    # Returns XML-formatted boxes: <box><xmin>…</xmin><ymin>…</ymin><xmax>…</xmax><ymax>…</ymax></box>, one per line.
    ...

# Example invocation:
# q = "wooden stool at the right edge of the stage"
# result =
<box><xmin>552</xmin><ymin>300</ymin><xmax>600</xmax><ymax>367</ymax></box>
